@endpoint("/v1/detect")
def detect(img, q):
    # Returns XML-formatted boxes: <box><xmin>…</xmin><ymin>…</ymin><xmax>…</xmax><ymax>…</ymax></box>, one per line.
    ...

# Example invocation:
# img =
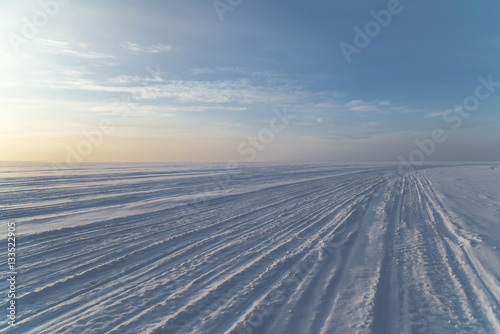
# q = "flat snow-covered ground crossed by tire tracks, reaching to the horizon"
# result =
<box><xmin>0</xmin><ymin>163</ymin><xmax>500</xmax><ymax>334</ymax></box>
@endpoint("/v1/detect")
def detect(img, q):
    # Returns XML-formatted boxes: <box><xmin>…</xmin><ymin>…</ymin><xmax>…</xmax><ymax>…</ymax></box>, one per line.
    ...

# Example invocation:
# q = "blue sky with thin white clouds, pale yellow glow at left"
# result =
<box><xmin>0</xmin><ymin>0</ymin><xmax>500</xmax><ymax>163</ymax></box>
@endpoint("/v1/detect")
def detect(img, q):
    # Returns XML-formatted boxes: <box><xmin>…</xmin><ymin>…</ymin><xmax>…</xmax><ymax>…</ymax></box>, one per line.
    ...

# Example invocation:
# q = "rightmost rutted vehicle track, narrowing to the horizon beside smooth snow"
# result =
<box><xmin>374</xmin><ymin>173</ymin><xmax>498</xmax><ymax>333</ymax></box>
